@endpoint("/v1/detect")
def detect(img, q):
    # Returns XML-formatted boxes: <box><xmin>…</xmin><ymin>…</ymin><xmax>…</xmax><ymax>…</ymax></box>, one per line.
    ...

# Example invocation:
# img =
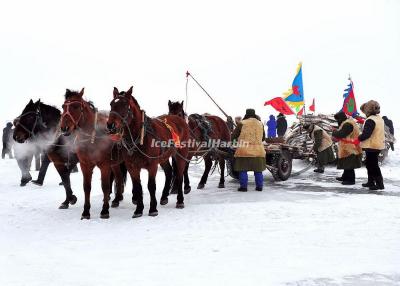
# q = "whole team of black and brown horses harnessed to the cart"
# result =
<box><xmin>13</xmin><ymin>87</ymin><xmax>230</xmax><ymax>219</ymax></box>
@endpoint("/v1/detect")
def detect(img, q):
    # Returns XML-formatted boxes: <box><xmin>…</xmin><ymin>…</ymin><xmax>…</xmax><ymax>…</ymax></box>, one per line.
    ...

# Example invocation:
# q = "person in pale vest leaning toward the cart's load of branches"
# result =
<box><xmin>304</xmin><ymin>124</ymin><xmax>336</xmax><ymax>173</ymax></box>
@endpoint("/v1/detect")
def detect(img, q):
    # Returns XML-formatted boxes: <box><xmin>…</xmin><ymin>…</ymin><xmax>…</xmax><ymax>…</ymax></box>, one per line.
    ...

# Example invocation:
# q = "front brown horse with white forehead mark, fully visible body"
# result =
<box><xmin>107</xmin><ymin>87</ymin><xmax>189</xmax><ymax>217</ymax></box>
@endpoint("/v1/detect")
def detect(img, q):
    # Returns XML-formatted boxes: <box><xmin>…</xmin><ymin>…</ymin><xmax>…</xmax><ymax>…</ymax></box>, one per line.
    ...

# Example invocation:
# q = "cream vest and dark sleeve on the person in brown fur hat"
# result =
<box><xmin>358</xmin><ymin>115</ymin><xmax>385</xmax><ymax>151</ymax></box>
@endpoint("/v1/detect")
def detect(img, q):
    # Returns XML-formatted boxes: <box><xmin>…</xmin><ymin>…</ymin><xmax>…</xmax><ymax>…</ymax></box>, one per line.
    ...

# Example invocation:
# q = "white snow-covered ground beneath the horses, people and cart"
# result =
<box><xmin>0</xmin><ymin>147</ymin><xmax>400</xmax><ymax>286</ymax></box>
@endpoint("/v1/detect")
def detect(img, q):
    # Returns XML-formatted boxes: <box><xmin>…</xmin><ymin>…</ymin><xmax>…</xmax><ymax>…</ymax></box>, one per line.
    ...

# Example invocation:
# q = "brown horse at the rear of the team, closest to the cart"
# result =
<box><xmin>168</xmin><ymin>101</ymin><xmax>231</xmax><ymax>192</ymax></box>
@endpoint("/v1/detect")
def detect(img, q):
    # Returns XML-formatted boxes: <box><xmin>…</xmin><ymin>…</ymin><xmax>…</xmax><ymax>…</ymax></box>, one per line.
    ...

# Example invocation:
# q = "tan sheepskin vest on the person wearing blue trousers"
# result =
<box><xmin>235</xmin><ymin>118</ymin><xmax>265</xmax><ymax>158</ymax></box>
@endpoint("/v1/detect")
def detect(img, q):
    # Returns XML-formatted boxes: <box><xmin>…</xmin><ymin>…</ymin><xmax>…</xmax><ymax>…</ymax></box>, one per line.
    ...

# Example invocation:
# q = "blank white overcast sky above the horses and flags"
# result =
<box><xmin>0</xmin><ymin>0</ymin><xmax>400</xmax><ymax>124</ymax></box>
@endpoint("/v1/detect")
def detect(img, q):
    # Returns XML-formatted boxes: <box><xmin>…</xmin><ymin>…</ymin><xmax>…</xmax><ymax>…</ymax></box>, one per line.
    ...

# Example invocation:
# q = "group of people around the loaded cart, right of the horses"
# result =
<box><xmin>232</xmin><ymin>100</ymin><xmax>394</xmax><ymax>192</ymax></box>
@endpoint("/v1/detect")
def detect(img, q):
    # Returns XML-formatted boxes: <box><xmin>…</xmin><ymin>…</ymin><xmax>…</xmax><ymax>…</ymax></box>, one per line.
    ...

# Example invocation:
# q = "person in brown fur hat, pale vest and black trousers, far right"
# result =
<box><xmin>354</xmin><ymin>100</ymin><xmax>385</xmax><ymax>190</ymax></box>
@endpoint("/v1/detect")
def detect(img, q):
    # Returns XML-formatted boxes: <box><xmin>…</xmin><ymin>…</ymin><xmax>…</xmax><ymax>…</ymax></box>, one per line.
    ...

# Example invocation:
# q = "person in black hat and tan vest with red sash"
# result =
<box><xmin>332</xmin><ymin>111</ymin><xmax>362</xmax><ymax>185</ymax></box>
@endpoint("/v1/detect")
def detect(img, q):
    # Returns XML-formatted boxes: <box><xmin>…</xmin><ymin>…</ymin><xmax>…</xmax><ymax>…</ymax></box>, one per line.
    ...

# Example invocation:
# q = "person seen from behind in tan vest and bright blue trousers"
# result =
<box><xmin>232</xmin><ymin>109</ymin><xmax>266</xmax><ymax>192</ymax></box>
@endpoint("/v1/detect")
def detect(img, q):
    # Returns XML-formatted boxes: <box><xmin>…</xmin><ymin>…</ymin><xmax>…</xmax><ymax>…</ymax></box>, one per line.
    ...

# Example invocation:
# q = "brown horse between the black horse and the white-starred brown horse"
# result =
<box><xmin>61</xmin><ymin>89</ymin><xmax>124</xmax><ymax>219</ymax></box>
